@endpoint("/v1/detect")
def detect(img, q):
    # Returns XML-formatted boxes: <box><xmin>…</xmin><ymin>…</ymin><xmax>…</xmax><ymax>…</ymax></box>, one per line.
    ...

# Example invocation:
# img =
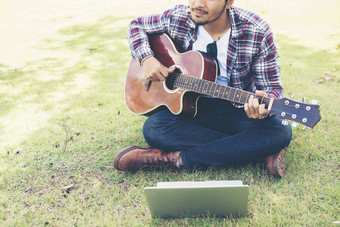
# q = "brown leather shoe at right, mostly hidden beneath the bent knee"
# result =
<box><xmin>266</xmin><ymin>150</ymin><xmax>286</xmax><ymax>177</ymax></box>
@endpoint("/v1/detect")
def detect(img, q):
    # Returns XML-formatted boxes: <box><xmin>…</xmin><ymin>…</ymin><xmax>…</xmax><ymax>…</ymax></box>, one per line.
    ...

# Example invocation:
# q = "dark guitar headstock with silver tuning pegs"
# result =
<box><xmin>271</xmin><ymin>98</ymin><xmax>321</xmax><ymax>128</ymax></box>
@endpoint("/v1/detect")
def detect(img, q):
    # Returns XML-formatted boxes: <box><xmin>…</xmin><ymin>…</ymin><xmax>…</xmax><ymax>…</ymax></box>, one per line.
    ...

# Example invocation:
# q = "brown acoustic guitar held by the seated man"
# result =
<box><xmin>125</xmin><ymin>34</ymin><xmax>321</xmax><ymax>128</ymax></box>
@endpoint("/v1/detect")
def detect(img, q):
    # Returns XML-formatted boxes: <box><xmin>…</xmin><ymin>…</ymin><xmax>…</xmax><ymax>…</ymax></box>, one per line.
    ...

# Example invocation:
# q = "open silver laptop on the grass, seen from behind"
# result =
<box><xmin>144</xmin><ymin>181</ymin><xmax>249</xmax><ymax>218</ymax></box>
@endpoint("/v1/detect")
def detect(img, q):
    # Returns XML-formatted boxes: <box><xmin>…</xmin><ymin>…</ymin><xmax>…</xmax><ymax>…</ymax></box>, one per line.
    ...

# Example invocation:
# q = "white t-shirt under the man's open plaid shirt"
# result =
<box><xmin>192</xmin><ymin>26</ymin><xmax>231</xmax><ymax>85</ymax></box>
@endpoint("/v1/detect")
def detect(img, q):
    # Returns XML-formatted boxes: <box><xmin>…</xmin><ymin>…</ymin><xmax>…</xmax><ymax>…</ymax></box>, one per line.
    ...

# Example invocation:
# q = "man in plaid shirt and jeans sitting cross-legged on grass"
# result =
<box><xmin>114</xmin><ymin>0</ymin><xmax>292</xmax><ymax>177</ymax></box>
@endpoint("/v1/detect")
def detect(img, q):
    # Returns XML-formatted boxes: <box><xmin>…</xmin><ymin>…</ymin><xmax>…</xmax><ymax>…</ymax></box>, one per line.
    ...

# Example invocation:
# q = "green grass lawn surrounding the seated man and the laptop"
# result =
<box><xmin>0</xmin><ymin>7</ymin><xmax>340</xmax><ymax>226</ymax></box>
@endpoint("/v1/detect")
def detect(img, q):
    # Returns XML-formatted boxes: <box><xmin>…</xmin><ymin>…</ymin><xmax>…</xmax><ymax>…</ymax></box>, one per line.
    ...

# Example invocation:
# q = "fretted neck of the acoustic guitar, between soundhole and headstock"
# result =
<box><xmin>170</xmin><ymin>74</ymin><xmax>270</xmax><ymax>106</ymax></box>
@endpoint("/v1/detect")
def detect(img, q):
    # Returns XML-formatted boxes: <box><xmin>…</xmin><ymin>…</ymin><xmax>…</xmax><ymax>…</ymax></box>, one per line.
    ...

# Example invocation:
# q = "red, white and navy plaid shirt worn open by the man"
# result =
<box><xmin>128</xmin><ymin>5</ymin><xmax>283</xmax><ymax>107</ymax></box>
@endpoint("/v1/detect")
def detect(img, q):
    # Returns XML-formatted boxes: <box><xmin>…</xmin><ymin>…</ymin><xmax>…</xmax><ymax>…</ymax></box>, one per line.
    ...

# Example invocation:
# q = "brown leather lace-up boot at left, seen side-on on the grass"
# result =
<box><xmin>113</xmin><ymin>146</ymin><xmax>179</xmax><ymax>172</ymax></box>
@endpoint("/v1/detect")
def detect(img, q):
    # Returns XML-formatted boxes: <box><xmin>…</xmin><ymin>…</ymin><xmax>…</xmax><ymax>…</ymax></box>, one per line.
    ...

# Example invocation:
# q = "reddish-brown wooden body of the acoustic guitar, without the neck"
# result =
<box><xmin>125</xmin><ymin>34</ymin><xmax>217</xmax><ymax>116</ymax></box>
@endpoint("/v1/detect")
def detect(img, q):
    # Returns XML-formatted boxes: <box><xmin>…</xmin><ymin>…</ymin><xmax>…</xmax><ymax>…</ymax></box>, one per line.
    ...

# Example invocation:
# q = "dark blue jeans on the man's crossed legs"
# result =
<box><xmin>143</xmin><ymin>97</ymin><xmax>292</xmax><ymax>171</ymax></box>
